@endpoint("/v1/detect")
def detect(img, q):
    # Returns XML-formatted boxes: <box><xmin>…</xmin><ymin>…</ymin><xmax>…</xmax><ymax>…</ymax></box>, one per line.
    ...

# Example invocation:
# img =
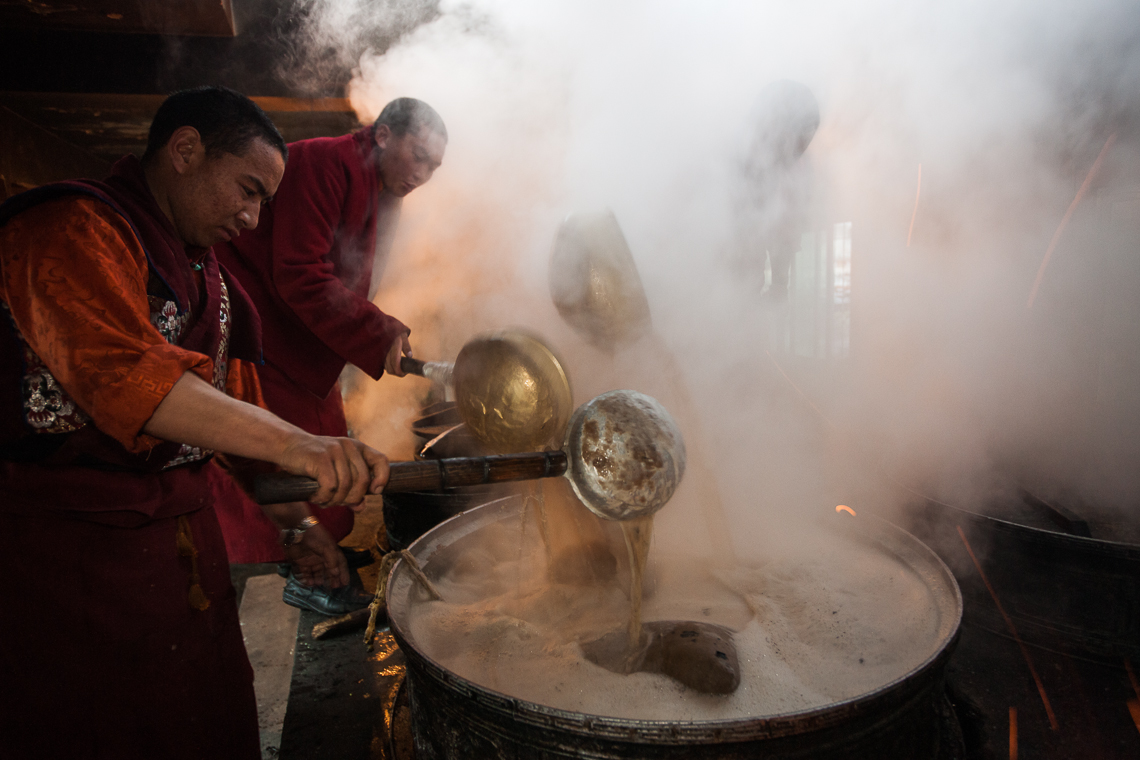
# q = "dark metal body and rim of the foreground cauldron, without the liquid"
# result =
<box><xmin>388</xmin><ymin>497</ymin><xmax>962</xmax><ymax>760</ymax></box>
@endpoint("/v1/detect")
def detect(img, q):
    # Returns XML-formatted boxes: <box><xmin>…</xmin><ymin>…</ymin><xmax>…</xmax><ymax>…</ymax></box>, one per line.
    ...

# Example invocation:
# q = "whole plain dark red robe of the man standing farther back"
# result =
<box><xmin>215</xmin><ymin>128</ymin><xmax>409</xmax><ymax>562</ymax></box>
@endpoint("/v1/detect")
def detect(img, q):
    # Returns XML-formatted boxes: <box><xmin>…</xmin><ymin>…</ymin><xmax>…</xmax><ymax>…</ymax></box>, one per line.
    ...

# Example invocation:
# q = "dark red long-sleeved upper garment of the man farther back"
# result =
<box><xmin>214</xmin><ymin>128</ymin><xmax>409</xmax><ymax>398</ymax></box>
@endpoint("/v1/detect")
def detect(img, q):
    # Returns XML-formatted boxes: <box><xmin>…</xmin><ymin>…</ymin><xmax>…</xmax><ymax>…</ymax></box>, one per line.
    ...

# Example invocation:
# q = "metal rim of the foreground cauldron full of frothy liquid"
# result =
<box><xmin>388</xmin><ymin>496</ymin><xmax>962</xmax><ymax>744</ymax></box>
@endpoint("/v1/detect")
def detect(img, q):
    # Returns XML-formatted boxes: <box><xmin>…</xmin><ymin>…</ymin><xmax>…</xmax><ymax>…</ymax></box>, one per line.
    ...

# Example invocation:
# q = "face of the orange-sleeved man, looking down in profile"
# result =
<box><xmin>169</xmin><ymin>138</ymin><xmax>285</xmax><ymax>248</ymax></box>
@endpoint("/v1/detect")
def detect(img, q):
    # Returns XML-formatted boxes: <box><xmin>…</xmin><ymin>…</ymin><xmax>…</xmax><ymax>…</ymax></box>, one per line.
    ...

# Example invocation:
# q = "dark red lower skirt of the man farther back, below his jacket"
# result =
<box><xmin>213</xmin><ymin>365</ymin><xmax>353</xmax><ymax>563</ymax></box>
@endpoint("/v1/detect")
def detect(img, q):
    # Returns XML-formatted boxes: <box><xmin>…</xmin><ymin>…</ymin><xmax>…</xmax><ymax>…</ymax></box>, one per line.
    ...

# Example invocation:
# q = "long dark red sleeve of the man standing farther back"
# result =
<box><xmin>266</xmin><ymin>141</ymin><xmax>407</xmax><ymax>377</ymax></box>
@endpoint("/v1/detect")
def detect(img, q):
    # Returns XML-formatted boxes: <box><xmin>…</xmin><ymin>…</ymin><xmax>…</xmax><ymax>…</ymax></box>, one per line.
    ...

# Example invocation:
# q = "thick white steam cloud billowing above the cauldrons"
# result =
<box><xmin>315</xmin><ymin>0</ymin><xmax>1140</xmax><ymax>549</ymax></box>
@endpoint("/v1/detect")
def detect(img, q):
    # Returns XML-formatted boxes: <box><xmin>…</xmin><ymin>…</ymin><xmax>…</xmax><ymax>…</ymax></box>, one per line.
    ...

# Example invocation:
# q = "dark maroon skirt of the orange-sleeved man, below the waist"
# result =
<box><xmin>0</xmin><ymin>499</ymin><xmax>261</xmax><ymax>760</ymax></box>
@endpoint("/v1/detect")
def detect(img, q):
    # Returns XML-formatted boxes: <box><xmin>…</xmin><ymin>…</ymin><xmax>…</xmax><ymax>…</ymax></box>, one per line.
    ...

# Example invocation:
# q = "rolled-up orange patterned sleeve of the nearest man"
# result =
<box><xmin>0</xmin><ymin>198</ymin><xmax>213</xmax><ymax>452</ymax></box>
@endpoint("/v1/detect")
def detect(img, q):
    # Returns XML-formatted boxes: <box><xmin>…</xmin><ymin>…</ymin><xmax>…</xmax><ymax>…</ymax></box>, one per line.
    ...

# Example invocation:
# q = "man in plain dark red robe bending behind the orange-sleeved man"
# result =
<box><xmin>215</xmin><ymin>98</ymin><xmax>447</xmax><ymax>614</ymax></box>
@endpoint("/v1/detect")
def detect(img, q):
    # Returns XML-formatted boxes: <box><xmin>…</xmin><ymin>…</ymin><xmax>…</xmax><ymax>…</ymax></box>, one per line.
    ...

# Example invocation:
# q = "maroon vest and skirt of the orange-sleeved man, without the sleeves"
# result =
<box><xmin>0</xmin><ymin>156</ymin><xmax>260</xmax><ymax>760</ymax></box>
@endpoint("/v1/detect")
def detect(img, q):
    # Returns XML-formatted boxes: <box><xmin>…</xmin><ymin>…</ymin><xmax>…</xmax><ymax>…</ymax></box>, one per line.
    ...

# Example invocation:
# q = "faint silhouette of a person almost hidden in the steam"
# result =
<box><xmin>738</xmin><ymin>80</ymin><xmax>820</xmax><ymax>304</ymax></box>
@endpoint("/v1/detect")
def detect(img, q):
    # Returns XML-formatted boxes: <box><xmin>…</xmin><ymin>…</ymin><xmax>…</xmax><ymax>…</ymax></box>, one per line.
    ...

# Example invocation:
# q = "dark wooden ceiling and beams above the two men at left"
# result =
<box><xmin>0</xmin><ymin>0</ymin><xmax>438</xmax><ymax>190</ymax></box>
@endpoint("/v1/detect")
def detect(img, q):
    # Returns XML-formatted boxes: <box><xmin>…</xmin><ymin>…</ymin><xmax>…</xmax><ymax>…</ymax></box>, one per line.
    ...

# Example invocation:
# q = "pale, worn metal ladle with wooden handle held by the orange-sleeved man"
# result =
<box><xmin>254</xmin><ymin>391</ymin><xmax>685</xmax><ymax>521</ymax></box>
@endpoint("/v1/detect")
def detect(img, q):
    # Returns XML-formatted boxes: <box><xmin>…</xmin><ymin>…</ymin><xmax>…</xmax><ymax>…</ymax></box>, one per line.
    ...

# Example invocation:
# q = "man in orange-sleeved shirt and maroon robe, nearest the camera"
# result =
<box><xmin>0</xmin><ymin>88</ymin><xmax>388</xmax><ymax>760</ymax></box>
